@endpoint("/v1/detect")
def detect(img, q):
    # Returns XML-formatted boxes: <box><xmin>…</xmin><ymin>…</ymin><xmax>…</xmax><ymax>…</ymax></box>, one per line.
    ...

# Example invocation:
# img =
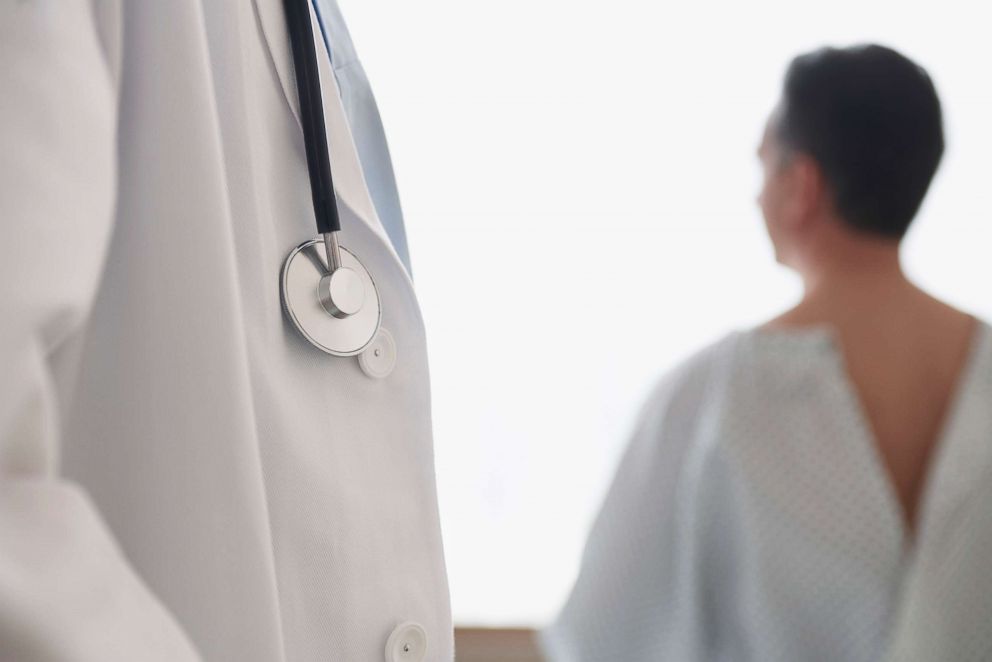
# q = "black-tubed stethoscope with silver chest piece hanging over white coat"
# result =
<box><xmin>280</xmin><ymin>0</ymin><xmax>395</xmax><ymax>366</ymax></box>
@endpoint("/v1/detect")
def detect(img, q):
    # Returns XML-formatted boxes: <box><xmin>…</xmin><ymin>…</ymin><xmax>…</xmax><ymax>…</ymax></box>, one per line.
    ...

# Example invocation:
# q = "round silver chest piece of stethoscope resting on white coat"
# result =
<box><xmin>280</xmin><ymin>238</ymin><xmax>382</xmax><ymax>356</ymax></box>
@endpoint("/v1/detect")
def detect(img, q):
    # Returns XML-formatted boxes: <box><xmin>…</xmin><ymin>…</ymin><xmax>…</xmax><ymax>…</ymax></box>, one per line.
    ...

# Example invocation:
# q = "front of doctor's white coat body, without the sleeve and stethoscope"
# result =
<box><xmin>42</xmin><ymin>0</ymin><xmax>452</xmax><ymax>662</ymax></box>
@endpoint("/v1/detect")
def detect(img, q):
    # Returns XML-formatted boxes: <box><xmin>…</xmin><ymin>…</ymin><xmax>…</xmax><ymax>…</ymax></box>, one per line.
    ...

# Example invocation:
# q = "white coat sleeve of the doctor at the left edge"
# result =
<box><xmin>0</xmin><ymin>0</ymin><xmax>198</xmax><ymax>662</ymax></box>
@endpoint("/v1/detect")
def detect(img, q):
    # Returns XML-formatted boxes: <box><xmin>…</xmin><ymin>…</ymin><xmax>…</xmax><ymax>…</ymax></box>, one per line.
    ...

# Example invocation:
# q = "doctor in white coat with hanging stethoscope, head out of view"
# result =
<box><xmin>0</xmin><ymin>0</ymin><xmax>452</xmax><ymax>662</ymax></box>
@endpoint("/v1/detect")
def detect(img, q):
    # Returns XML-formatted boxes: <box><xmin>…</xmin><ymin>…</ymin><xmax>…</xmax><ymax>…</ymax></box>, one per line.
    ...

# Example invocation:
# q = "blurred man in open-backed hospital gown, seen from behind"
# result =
<box><xmin>543</xmin><ymin>46</ymin><xmax>992</xmax><ymax>662</ymax></box>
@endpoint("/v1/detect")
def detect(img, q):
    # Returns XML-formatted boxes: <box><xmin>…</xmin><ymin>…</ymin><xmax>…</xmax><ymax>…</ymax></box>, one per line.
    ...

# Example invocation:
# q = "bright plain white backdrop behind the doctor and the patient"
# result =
<box><xmin>339</xmin><ymin>0</ymin><xmax>992</xmax><ymax>625</ymax></box>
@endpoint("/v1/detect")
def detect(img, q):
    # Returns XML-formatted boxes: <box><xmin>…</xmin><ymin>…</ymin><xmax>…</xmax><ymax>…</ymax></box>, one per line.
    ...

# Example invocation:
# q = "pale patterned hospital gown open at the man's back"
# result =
<box><xmin>542</xmin><ymin>323</ymin><xmax>992</xmax><ymax>662</ymax></box>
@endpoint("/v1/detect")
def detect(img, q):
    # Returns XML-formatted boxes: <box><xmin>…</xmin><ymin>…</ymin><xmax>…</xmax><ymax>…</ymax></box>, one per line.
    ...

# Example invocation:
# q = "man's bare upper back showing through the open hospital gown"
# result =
<box><xmin>767</xmin><ymin>287</ymin><xmax>977</xmax><ymax>531</ymax></box>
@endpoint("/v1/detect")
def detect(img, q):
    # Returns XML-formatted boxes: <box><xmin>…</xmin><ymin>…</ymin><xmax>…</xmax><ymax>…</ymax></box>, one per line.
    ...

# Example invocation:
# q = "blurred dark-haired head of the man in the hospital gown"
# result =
<box><xmin>759</xmin><ymin>45</ymin><xmax>944</xmax><ymax>270</ymax></box>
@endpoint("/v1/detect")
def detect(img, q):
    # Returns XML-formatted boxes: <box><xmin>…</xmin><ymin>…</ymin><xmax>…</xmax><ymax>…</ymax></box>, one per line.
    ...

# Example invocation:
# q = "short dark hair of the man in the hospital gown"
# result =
<box><xmin>777</xmin><ymin>45</ymin><xmax>944</xmax><ymax>238</ymax></box>
